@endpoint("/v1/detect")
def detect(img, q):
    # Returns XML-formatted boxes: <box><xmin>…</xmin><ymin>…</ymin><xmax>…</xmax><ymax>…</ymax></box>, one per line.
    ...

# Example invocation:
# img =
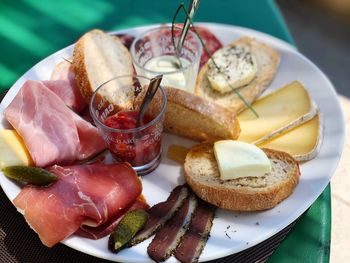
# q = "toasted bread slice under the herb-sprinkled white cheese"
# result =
<box><xmin>195</xmin><ymin>37</ymin><xmax>280</xmax><ymax>113</ymax></box>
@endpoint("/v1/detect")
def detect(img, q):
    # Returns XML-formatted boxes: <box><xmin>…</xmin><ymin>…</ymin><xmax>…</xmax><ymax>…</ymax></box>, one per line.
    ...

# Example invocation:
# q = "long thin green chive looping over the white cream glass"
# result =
<box><xmin>171</xmin><ymin>1</ymin><xmax>259</xmax><ymax>118</ymax></box>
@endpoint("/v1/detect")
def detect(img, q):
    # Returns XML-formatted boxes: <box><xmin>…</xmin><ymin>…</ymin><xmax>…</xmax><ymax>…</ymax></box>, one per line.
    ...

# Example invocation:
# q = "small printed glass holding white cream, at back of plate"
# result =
<box><xmin>130</xmin><ymin>26</ymin><xmax>202</xmax><ymax>92</ymax></box>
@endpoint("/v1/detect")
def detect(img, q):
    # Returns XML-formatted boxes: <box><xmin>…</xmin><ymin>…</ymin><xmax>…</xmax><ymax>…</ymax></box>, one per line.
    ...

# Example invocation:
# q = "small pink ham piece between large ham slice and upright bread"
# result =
<box><xmin>47</xmin><ymin>61</ymin><xmax>87</xmax><ymax>113</ymax></box>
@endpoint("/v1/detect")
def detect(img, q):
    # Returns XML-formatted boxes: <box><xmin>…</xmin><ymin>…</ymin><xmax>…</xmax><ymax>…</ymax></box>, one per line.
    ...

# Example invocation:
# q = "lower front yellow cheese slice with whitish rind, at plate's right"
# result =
<box><xmin>258</xmin><ymin>113</ymin><xmax>323</xmax><ymax>161</ymax></box>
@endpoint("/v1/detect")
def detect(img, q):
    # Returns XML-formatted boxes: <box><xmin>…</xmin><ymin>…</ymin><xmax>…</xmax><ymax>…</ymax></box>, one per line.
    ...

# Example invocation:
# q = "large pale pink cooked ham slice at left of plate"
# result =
<box><xmin>4</xmin><ymin>80</ymin><xmax>106</xmax><ymax>167</ymax></box>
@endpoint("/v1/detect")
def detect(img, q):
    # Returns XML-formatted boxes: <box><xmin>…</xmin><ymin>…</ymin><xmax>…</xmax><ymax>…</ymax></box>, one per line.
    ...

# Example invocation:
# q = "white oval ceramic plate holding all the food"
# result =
<box><xmin>0</xmin><ymin>23</ymin><xmax>344</xmax><ymax>263</ymax></box>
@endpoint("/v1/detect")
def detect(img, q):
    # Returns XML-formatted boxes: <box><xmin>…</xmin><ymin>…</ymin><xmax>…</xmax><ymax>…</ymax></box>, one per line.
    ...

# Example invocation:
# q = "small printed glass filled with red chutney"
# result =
<box><xmin>90</xmin><ymin>75</ymin><xmax>166</xmax><ymax>175</ymax></box>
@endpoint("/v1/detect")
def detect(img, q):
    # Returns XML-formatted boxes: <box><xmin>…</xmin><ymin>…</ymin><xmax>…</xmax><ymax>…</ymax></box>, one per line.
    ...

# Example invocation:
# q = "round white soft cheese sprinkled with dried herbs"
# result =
<box><xmin>207</xmin><ymin>46</ymin><xmax>257</xmax><ymax>93</ymax></box>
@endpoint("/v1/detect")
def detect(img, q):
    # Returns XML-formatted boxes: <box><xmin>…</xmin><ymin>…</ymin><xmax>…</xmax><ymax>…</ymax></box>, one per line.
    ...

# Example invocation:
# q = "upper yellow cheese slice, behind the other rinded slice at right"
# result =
<box><xmin>238</xmin><ymin>81</ymin><xmax>317</xmax><ymax>143</ymax></box>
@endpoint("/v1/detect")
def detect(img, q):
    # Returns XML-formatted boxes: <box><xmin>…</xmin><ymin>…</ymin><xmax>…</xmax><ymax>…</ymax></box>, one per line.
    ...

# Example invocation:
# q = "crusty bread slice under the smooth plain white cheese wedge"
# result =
<box><xmin>184</xmin><ymin>142</ymin><xmax>300</xmax><ymax>211</ymax></box>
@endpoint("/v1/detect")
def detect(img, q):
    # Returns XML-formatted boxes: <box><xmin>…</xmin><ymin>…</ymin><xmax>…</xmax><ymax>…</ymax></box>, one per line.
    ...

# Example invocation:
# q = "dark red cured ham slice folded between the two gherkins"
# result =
<box><xmin>13</xmin><ymin>163</ymin><xmax>142</xmax><ymax>247</ymax></box>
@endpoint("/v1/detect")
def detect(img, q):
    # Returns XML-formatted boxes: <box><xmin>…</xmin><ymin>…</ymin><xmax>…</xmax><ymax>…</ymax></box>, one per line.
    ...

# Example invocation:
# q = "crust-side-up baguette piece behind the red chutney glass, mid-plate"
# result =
<box><xmin>145</xmin><ymin>87</ymin><xmax>240</xmax><ymax>141</ymax></box>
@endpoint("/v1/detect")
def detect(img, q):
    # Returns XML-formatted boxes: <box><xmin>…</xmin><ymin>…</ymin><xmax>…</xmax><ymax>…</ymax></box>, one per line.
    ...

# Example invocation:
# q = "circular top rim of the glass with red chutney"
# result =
<box><xmin>89</xmin><ymin>75</ymin><xmax>167</xmax><ymax>133</ymax></box>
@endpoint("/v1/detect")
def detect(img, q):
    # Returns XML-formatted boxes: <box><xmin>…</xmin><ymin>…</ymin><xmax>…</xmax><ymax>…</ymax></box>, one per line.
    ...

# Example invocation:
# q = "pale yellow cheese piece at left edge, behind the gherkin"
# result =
<box><xmin>0</xmin><ymin>130</ymin><xmax>33</xmax><ymax>169</ymax></box>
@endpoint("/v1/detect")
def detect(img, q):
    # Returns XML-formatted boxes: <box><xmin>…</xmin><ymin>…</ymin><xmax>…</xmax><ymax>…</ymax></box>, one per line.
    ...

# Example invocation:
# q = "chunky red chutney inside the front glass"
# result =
<box><xmin>104</xmin><ymin>111</ymin><xmax>161</xmax><ymax>167</ymax></box>
